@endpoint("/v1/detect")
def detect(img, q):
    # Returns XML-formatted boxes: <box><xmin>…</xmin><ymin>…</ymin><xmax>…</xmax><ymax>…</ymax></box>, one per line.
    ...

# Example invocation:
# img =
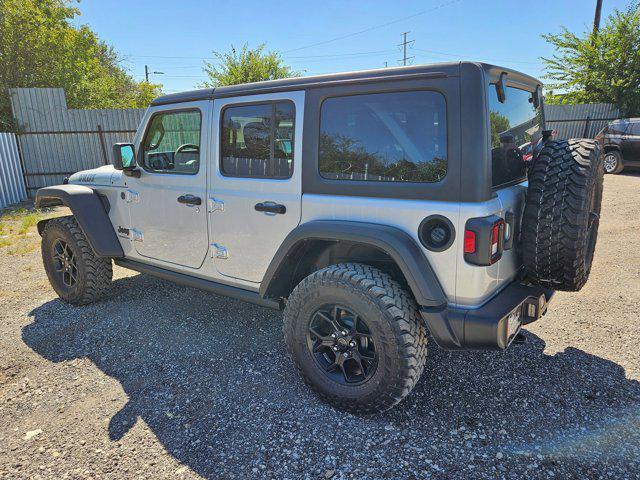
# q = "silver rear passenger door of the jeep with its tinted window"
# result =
<box><xmin>209</xmin><ymin>92</ymin><xmax>304</xmax><ymax>282</ymax></box>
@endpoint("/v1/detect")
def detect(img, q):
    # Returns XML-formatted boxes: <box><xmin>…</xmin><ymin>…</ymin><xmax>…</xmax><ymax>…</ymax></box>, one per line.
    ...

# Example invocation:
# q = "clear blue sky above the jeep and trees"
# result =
<box><xmin>77</xmin><ymin>0</ymin><xmax>628</xmax><ymax>93</ymax></box>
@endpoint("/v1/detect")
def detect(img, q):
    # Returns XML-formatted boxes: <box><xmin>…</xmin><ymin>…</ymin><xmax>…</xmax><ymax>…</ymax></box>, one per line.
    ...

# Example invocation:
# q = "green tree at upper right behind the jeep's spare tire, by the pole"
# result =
<box><xmin>542</xmin><ymin>2</ymin><xmax>640</xmax><ymax>116</ymax></box>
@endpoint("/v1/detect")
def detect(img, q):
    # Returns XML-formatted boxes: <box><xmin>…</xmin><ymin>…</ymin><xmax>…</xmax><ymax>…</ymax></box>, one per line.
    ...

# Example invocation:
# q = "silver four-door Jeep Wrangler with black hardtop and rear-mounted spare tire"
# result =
<box><xmin>36</xmin><ymin>62</ymin><xmax>603</xmax><ymax>413</ymax></box>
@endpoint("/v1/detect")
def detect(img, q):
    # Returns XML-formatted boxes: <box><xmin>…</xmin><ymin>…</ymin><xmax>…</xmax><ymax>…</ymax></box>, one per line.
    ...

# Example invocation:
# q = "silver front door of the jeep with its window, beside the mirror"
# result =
<box><xmin>127</xmin><ymin>101</ymin><xmax>209</xmax><ymax>268</ymax></box>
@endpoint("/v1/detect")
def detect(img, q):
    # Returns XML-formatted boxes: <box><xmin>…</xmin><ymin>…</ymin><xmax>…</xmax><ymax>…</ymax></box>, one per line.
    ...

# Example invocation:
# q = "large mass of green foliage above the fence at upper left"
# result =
<box><xmin>0</xmin><ymin>0</ymin><xmax>160</xmax><ymax>130</ymax></box>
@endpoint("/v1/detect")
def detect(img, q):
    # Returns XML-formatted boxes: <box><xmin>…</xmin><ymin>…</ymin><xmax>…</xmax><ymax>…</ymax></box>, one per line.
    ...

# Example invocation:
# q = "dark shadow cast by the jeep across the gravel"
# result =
<box><xmin>22</xmin><ymin>275</ymin><xmax>640</xmax><ymax>478</ymax></box>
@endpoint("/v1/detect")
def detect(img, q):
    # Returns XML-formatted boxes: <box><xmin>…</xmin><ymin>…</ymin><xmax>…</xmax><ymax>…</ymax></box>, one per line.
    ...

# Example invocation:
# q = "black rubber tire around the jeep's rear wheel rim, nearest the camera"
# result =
<box><xmin>284</xmin><ymin>263</ymin><xmax>427</xmax><ymax>414</ymax></box>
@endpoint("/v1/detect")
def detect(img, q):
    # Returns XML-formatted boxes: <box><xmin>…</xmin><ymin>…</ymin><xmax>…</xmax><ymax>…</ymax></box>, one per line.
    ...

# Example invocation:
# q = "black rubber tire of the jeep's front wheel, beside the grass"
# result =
<box><xmin>42</xmin><ymin>216</ymin><xmax>113</xmax><ymax>305</ymax></box>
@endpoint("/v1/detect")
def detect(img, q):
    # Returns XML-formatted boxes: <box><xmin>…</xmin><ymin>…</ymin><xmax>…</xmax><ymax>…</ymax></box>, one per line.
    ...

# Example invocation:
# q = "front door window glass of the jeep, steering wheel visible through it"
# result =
<box><xmin>142</xmin><ymin>110</ymin><xmax>201</xmax><ymax>175</ymax></box>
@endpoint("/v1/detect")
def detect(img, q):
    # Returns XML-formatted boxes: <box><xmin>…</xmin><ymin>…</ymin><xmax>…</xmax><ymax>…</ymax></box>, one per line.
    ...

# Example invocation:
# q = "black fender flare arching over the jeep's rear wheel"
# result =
<box><xmin>260</xmin><ymin>220</ymin><xmax>447</xmax><ymax>308</ymax></box>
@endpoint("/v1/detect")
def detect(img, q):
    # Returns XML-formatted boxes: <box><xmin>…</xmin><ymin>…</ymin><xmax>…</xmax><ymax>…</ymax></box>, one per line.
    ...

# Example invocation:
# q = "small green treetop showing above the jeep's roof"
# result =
<box><xmin>200</xmin><ymin>43</ymin><xmax>299</xmax><ymax>87</ymax></box>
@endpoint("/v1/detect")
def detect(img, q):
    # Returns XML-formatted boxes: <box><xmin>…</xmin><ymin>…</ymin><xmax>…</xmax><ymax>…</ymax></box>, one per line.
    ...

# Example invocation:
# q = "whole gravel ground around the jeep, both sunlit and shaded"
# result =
<box><xmin>0</xmin><ymin>174</ymin><xmax>640</xmax><ymax>479</ymax></box>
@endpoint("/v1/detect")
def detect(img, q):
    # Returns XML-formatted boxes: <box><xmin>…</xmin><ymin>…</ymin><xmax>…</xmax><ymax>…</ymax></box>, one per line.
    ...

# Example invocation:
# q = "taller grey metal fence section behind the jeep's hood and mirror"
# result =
<box><xmin>9</xmin><ymin>88</ymin><xmax>145</xmax><ymax>196</ymax></box>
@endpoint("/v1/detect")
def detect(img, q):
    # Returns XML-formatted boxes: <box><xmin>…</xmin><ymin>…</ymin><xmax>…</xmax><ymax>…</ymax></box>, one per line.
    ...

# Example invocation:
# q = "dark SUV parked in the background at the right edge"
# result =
<box><xmin>596</xmin><ymin>118</ymin><xmax>640</xmax><ymax>173</ymax></box>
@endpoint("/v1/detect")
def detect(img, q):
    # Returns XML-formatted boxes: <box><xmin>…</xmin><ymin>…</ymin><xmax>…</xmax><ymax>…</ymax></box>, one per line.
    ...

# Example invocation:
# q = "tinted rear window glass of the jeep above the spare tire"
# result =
<box><xmin>487</xmin><ymin>84</ymin><xmax>543</xmax><ymax>187</ymax></box>
